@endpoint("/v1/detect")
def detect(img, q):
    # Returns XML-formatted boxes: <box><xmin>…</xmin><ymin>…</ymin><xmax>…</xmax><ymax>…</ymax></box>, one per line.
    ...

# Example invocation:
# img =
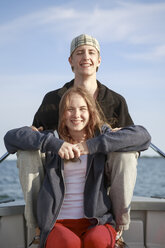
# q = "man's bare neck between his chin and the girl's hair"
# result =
<box><xmin>74</xmin><ymin>77</ymin><xmax>98</xmax><ymax>98</ymax></box>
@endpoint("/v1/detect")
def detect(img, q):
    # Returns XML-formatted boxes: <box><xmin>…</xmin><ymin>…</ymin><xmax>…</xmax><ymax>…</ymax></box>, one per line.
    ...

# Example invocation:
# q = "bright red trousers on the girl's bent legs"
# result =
<box><xmin>46</xmin><ymin>219</ymin><xmax>116</xmax><ymax>248</ymax></box>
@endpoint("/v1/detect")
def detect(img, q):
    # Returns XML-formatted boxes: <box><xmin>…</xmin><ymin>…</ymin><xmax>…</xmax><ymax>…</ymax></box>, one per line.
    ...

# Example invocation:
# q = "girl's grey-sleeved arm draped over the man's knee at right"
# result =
<box><xmin>86</xmin><ymin>125</ymin><xmax>151</xmax><ymax>154</ymax></box>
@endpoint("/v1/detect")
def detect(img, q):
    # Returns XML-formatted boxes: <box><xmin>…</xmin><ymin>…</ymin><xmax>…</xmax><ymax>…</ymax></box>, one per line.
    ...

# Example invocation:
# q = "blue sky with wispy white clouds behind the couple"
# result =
<box><xmin>0</xmin><ymin>0</ymin><xmax>165</xmax><ymax>156</ymax></box>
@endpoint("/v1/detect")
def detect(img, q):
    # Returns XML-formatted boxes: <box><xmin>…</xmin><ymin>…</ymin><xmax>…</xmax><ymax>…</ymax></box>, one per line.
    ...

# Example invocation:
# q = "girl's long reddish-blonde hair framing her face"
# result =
<box><xmin>58</xmin><ymin>87</ymin><xmax>105</xmax><ymax>143</ymax></box>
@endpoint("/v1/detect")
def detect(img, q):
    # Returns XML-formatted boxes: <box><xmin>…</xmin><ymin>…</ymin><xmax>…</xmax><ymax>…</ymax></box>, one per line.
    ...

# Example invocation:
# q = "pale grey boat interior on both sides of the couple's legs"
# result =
<box><xmin>0</xmin><ymin>197</ymin><xmax>165</xmax><ymax>248</ymax></box>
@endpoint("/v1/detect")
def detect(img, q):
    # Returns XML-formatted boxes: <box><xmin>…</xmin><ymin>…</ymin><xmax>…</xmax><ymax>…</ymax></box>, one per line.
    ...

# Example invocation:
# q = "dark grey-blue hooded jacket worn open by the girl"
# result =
<box><xmin>4</xmin><ymin>125</ymin><xmax>151</xmax><ymax>248</ymax></box>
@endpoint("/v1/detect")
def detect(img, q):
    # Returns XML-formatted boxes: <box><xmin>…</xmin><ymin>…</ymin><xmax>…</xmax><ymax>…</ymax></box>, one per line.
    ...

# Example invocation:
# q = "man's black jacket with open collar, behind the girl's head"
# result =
<box><xmin>33</xmin><ymin>80</ymin><xmax>133</xmax><ymax>130</ymax></box>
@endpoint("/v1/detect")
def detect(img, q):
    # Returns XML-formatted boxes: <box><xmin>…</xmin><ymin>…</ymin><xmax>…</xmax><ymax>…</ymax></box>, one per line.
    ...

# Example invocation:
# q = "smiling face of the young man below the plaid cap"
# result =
<box><xmin>69</xmin><ymin>45</ymin><xmax>101</xmax><ymax>76</ymax></box>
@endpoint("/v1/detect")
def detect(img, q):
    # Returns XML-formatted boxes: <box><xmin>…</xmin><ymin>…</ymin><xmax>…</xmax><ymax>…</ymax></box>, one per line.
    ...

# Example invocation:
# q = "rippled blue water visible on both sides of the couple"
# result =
<box><xmin>0</xmin><ymin>157</ymin><xmax>165</xmax><ymax>201</ymax></box>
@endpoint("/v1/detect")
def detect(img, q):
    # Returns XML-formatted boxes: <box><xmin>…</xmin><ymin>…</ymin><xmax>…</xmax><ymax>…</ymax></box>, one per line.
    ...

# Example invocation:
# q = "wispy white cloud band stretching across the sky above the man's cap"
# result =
<box><xmin>0</xmin><ymin>2</ymin><xmax>165</xmax><ymax>44</ymax></box>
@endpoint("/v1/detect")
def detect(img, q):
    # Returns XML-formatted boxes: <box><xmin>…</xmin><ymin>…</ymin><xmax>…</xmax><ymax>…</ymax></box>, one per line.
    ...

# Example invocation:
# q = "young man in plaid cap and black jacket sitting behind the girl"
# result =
<box><xmin>18</xmin><ymin>34</ymin><xmax>138</xmax><ymax>247</ymax></box>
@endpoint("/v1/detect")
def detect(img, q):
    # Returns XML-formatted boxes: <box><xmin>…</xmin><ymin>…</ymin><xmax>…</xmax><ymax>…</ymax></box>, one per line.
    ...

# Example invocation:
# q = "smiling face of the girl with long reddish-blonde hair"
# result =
<box><xmin>65</xmin><ymin>94</ymin><xmax>89</xmax><ymax>135</ymax></box>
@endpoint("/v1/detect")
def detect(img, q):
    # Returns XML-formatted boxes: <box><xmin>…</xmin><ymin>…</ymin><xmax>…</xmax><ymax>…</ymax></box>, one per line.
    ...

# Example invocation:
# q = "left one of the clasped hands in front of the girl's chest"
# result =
<box><xmin>58</xmin><ymin>142</ymin><xmax>81</xmax><ymax>160</ymax></box>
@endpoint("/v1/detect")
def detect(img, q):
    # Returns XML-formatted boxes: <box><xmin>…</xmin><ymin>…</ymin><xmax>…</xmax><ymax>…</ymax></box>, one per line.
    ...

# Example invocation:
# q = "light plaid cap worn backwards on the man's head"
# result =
<box><xmin>70</xmin><ymin>34</ymin><xmax>100</xmax><ymax>56</ymax></box>
